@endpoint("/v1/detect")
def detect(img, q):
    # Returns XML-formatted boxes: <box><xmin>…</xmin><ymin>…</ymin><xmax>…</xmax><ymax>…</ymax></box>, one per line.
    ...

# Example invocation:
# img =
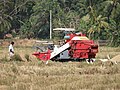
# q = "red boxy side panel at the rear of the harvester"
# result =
<box><xmin>69</xmin><ymin>40</ymin><xmax>98</xmax><ymax>59</ymax></box>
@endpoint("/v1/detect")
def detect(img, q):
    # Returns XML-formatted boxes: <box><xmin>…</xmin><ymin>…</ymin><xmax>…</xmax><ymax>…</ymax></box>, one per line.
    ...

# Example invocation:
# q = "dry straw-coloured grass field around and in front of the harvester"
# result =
<box><xmin>0</xmin><ymin>41</ymin><xmax>120</xmax><ymax>90</ymax></box>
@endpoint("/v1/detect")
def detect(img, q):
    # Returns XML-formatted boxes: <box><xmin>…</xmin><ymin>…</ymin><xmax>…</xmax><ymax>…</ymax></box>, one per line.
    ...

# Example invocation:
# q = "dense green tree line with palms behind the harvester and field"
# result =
<box><xmin>0</xmin><ymin>0</ymin><xmax>120</xmax><ymax>46</ymax></box>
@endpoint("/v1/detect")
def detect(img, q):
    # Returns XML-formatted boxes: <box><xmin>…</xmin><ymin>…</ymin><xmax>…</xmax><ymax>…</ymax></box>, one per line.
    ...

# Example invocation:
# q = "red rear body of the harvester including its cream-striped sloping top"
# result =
<box><xmin>66</xmin><ymin>33</ymin><xmax>98</xmax><ymax>59</ymax></box>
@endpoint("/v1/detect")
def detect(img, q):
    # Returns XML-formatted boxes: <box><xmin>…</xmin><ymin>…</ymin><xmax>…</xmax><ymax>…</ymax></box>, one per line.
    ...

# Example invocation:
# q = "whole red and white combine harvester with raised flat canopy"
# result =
<box><xmin>33</xmin><ymin>28</ymin><xmax>98</xmax><ymax>63</ymax></box>
